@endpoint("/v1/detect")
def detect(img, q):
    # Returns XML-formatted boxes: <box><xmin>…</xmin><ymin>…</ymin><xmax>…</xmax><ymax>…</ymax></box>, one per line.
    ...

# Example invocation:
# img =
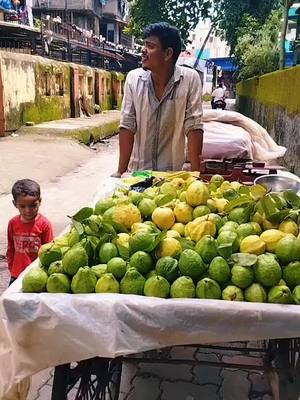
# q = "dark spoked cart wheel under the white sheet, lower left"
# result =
<box><xmin>52</xmin><ymin>357</ymin><xmax>122</xmax><ymax>400</ymax></box>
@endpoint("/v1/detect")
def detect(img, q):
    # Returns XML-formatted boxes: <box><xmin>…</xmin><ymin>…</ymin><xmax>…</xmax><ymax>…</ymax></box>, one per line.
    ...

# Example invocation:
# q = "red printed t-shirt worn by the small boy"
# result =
<box><xmin>6</xmin><ymin>214</ymin><xmax>53</xmax><ymax>278</ymax></box>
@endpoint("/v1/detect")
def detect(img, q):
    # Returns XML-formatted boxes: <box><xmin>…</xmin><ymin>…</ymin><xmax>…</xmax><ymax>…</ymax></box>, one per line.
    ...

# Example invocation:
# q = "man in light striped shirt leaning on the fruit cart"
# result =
<box><xmin>113</xmin><ymin>22</ymin><xmax>203</xmax><ymax>177</ymax></box>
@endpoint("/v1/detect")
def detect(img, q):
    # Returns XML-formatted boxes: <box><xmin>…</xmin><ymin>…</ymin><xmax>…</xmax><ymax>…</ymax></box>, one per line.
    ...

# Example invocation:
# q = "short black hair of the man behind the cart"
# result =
<box><xmin>144</xmin><ymin>22</ymin><xmax>182</xmax><ymax>65</ymax></box>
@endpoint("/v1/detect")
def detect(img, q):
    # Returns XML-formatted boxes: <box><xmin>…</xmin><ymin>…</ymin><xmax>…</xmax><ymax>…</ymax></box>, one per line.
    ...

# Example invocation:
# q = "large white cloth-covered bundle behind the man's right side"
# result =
<box><xmin>203</xmin><ymin>109</ymin><xmax>286</xmax><ymax>161</ymax></box>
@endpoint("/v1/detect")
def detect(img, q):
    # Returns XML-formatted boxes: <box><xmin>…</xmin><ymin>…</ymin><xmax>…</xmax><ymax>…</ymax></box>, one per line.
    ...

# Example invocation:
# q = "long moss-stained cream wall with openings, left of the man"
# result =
<box><xmin>0</xmin><ymin>51</ymin><xmax>125</xmax><ymax>136</ymax></box>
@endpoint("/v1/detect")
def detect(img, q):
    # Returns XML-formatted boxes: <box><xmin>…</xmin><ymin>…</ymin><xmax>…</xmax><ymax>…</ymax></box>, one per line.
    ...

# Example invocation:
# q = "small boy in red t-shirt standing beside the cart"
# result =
<box><xmin>6</xmin><ymin>179</ymin><xmax>53</xmax><ymax>284</ymax></box>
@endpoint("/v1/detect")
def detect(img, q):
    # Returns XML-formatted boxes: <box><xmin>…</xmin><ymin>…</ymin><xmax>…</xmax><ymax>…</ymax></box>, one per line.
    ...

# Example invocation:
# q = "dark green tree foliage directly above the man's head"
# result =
<box><xmin>126</xmin><ymin>0</ymin><xmax>212</xmax><ymax>44</ymax></box>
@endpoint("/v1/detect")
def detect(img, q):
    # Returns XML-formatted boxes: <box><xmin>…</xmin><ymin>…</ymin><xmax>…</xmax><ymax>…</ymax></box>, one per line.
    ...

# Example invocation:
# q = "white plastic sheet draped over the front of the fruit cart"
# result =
<box><xmin>0</xmin><ymin>281</ymin><xmax>300</xmax><ymax>398</ymax></box>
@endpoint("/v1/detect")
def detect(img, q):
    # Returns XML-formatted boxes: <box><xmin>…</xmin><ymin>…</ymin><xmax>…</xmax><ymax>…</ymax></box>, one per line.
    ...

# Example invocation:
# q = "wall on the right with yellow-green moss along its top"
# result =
<box><xmin>237</xmin><ymin>66</ymin><xmax>300</xmax><ymax>175</ymax></box>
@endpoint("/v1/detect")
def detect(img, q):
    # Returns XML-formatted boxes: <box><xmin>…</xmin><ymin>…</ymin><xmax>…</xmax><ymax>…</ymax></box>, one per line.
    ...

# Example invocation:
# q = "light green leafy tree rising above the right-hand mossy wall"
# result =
<box><xmin>235</xmin><ymin>10</ymin><xmax>282</xmax><ymax>80</ymax></box>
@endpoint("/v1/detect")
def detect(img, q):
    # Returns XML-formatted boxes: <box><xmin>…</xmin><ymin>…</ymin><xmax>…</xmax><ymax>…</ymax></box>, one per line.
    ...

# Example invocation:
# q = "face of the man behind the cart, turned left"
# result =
<box><xmin>142</xmin><ymin>36</ymin><xmax>173</xmax><ymax>72</ymax></box>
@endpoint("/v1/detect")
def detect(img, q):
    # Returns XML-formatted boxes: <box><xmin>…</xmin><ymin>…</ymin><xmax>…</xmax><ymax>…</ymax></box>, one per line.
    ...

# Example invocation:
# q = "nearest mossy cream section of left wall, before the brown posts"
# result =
<box><xmin>0</xmin><ymin>52</ymin><xmax>70</xmax><ymax>130</ymax></box>
